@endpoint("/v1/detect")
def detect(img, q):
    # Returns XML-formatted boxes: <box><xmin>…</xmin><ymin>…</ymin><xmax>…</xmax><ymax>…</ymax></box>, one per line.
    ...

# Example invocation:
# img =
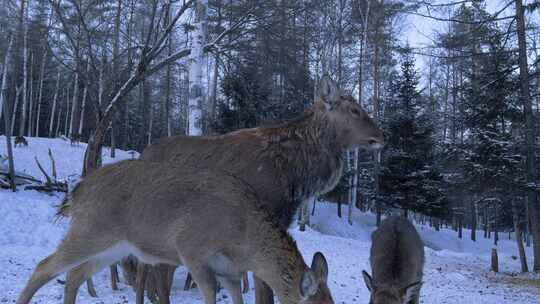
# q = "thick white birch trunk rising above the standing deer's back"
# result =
<box><xmin>188</xmin><ymin>0</ymin><xmax>208</xmax><ymax>136</ymax></box>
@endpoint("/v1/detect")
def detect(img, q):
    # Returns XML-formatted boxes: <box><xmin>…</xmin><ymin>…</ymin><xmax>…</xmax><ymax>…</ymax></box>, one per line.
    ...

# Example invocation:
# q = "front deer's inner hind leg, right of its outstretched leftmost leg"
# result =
<box><xmin>64</xmin><ymin>259</ymin><xmax>114</xmax><ymax>304</ymax></box>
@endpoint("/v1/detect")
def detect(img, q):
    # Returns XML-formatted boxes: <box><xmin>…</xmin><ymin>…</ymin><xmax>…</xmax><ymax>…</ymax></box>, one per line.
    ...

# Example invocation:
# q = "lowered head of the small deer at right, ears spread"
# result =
<box><xmin>362</xmin><ymin>271</ymin><xmax>422</xmax><ymax>304</ymax></box>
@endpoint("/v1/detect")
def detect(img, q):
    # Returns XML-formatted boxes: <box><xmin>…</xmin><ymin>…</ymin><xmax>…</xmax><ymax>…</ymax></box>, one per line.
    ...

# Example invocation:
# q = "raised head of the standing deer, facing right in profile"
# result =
<box><xmin>316</xmin><ymin>76</ymin><xmax>384</xmax><ymax>149</ymax></box>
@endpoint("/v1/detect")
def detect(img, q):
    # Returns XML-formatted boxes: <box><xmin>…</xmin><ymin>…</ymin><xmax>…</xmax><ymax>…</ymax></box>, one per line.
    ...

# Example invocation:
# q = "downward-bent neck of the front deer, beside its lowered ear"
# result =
<box><xmin>251</xmin><ymin>218</ymin><xmax>308</xmax><ymax>304</ymax></box>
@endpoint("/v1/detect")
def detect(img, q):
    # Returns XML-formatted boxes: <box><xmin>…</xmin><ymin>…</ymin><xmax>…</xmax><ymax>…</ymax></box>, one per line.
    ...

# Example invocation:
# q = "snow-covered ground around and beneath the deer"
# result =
<box><xmin>0</xmin><ymin>136</ymin><xmax>540</xmax><ymax>304</ymax></box>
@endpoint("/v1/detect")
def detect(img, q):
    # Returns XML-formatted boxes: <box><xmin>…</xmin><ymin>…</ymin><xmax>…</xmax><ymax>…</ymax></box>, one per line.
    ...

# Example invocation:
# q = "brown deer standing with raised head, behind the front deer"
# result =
<box><xmin>135</xmin><ymin>77</ymin><xmax>384</xmax><ymax>304</ymax></box>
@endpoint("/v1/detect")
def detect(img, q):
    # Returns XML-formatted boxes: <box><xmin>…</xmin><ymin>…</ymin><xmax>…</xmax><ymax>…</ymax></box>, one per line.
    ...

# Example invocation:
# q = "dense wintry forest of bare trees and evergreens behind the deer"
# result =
<box><xmin>0</xmin><ymin>0</ymin><xmax>540</xmax><ymax>271</ymax></box>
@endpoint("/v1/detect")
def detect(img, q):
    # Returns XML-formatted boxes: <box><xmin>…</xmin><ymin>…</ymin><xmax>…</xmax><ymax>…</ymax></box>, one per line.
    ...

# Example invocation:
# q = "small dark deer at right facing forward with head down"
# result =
<box><xmin>362</xmin><ymin>216</ymin><xmax>424</xmax><ymax>304</ymax></box>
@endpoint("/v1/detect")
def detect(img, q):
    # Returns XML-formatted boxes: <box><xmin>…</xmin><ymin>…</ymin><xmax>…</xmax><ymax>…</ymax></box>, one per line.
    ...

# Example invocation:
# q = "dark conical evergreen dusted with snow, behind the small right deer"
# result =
<box><xmin>380</xmin><ymin>50</ymin><xmax>446</xmax><ymax>216</ymax></box>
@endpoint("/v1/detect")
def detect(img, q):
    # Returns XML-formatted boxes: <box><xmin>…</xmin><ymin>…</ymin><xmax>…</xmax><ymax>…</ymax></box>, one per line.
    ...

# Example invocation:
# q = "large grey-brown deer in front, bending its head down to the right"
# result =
<box><xmin>16</xmin><ymin>160</ymin><xmax>334</xmax><ymax>304</ymax></box>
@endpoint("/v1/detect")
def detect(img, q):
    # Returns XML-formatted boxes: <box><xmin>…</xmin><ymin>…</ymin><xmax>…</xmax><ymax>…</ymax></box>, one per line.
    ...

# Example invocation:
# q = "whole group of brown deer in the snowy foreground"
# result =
<box><xmin>17</xmin><ymin>77</ymin><xmax>424</xmax><ymax>304</ymax></box>
